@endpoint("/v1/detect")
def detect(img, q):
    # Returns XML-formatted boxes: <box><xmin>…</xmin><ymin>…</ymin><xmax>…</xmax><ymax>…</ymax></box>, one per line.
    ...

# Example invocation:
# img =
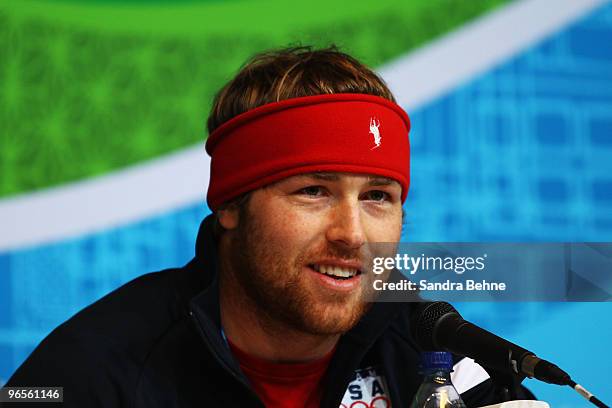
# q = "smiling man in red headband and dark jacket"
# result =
<box><xmin>7</xmin><ymin>48</ymin><xmax>532</xmax><ymax>408</ymax></box>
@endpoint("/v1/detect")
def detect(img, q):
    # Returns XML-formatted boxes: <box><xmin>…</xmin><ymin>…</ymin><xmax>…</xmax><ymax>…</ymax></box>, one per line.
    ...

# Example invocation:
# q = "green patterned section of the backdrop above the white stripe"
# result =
<box><xmin>0</xmin><ymin>0</ymin><xmax>502</xmax><ymax>196</ymax></box>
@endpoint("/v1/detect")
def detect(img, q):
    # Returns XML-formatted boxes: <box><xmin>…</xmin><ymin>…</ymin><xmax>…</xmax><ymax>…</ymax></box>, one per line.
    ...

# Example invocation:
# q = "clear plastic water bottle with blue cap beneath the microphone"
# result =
<box><xmin>410</xmin><ymin>351</ymin><xmax>467</xmax><ymax>408</ymax></box>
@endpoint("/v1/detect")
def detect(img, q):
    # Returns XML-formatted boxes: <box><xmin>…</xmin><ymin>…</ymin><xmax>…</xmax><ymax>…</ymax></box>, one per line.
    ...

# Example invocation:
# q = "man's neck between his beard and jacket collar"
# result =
<box><xmin>219</xmin><ymin>237</ymin><xmax>340</xmax><ymax>363</ymax></box>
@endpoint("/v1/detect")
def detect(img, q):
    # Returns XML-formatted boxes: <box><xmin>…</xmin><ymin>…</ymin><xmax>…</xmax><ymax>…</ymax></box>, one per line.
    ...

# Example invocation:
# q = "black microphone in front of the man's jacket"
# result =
<box><xmin>410</xmin><ymin>302</ymin><xmax>571</xmax><ymax>385</ymax></box>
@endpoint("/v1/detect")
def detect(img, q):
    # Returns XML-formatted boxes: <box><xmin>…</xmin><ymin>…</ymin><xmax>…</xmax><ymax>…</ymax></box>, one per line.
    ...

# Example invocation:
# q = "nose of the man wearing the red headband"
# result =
<box><xmin>326</xmin><ymin>203</ymin><xmax>366</xmax><ymax>249</ymax></box>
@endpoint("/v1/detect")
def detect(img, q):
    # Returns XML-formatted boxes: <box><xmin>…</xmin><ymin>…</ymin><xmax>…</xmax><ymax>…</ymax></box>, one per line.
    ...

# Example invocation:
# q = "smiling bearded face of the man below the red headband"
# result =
<box><xmin>220</xmin><ymin>173</ymin><xmax>402</xmax><ymax>335</ymax></box>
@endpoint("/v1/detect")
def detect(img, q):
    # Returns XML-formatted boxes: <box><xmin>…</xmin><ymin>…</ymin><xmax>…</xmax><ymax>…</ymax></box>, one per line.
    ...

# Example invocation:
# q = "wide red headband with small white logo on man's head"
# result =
<box><xmin>206</xmin><ymin>94</ymin><xmax>410</xmax><ymax>210</ymax></box>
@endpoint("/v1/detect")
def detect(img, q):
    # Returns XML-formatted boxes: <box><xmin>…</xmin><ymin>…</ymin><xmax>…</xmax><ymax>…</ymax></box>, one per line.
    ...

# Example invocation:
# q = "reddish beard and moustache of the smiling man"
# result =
<box><xmin>227</xmin><ymin>210</ymin><xmax>370</xmax><ymax>335</ymax></box>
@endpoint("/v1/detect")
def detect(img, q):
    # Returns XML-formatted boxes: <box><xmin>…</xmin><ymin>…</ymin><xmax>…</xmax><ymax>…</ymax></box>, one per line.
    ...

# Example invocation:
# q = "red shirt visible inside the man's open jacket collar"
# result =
<box><xmin>228</xmin><ymin>341</ymin><xmax>334</xmax><ymax>408</ymax></box>
